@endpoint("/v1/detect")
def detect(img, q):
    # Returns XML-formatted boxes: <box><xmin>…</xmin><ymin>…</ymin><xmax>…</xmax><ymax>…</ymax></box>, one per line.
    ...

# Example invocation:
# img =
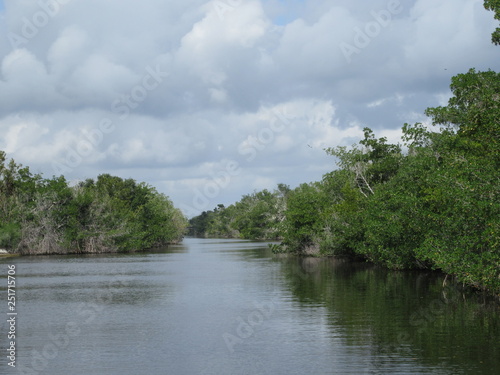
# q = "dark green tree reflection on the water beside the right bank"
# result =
<box><xmin>276</xmin><ymin>257</ymin><xmax>500</xmax><ymax>373</ymax></box>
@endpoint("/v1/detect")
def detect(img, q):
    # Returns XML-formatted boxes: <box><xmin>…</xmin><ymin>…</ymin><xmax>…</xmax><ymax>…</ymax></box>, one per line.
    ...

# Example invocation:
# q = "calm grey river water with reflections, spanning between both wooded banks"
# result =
<box><xmin>0</xmin><ymin>238</ymin><xmax>500</xmax><ymax>375</ymax></box>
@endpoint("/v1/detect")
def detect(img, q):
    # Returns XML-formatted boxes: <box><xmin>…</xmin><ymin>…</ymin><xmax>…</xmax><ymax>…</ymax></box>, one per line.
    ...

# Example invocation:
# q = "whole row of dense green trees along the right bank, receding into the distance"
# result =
<box><xmin>190</xmin><ymin>1</ymin><xmax>500</xmax><ymax>293</ymax></box>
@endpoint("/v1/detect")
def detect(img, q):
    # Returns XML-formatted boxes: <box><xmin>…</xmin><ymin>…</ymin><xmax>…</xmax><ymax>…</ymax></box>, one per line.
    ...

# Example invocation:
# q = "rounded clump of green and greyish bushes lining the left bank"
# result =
<box><xmin>0</xmin><ymin>151</ymin><xmax>187</xmax><ymax>254</ymax></box>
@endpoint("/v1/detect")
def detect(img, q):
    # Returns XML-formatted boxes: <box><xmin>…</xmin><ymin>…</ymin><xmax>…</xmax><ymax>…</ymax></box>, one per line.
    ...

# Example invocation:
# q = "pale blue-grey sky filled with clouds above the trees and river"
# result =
<box><xmin>0</xmin><ymin>0</ymin><xmax>500</xmax><ymax>217</ymax></box>
